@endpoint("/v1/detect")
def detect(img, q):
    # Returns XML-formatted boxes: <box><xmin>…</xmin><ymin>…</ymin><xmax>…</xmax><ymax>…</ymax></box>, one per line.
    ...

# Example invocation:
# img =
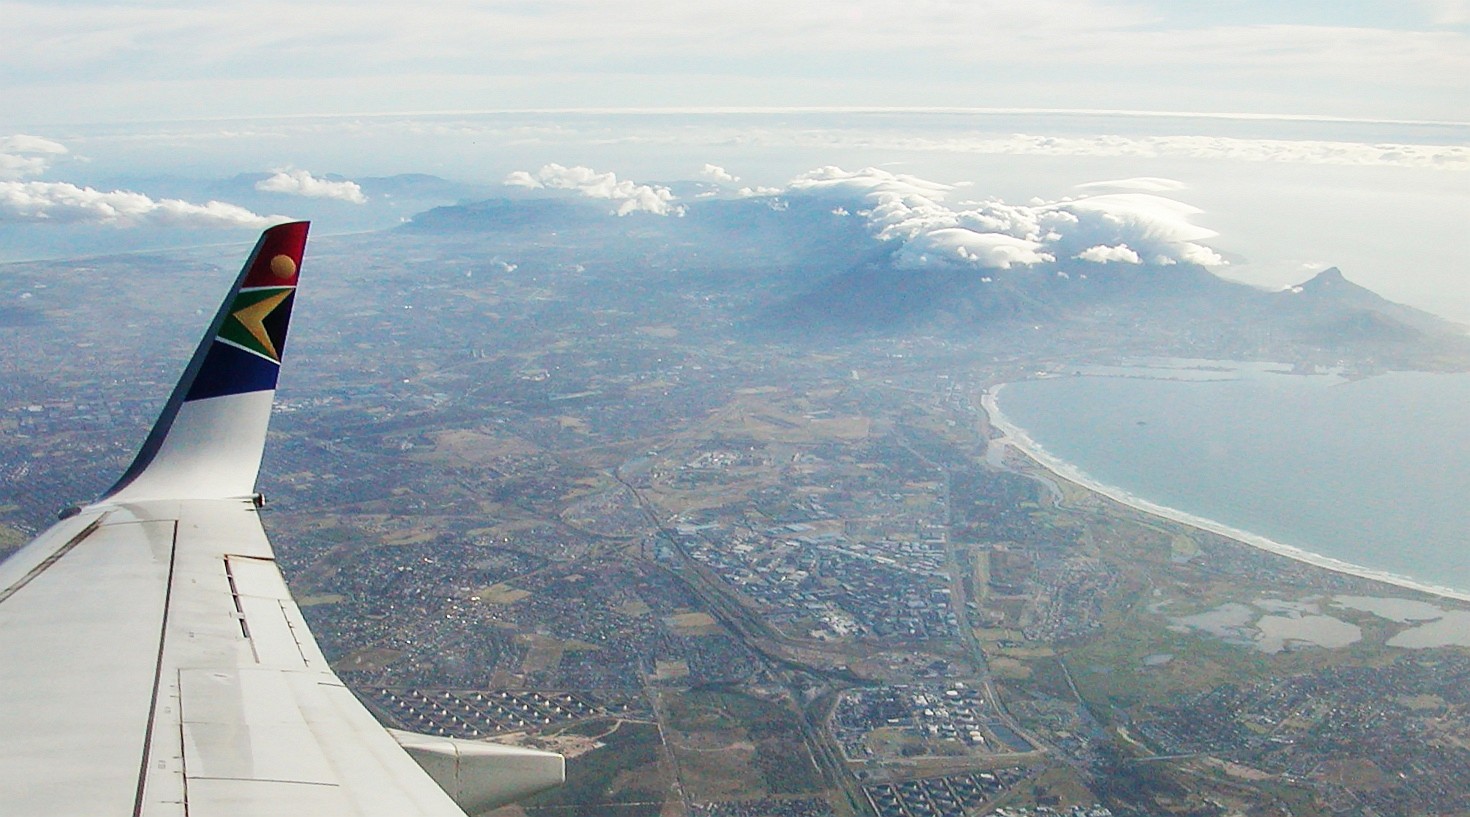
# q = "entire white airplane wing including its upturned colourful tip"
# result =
<box><xmin>0</xmin><ymin>222</ymin><xmax>563</xmax><ymax>817</ymax></box>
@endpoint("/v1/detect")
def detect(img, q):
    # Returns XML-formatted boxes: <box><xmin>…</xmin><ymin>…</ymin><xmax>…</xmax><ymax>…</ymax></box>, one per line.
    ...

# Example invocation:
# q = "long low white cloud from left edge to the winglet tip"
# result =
<box><xmin>0</xmin><ymin>181</ymin><xmax>290</xmax><ymax>229</ymax></box>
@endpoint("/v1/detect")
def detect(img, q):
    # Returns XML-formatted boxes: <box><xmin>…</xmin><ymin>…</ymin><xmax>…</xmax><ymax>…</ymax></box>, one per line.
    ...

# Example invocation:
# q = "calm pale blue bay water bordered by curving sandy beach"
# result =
<box><xmin>998</xmin><ymin>361</ymin><xmax>1470</xmax><ymax>592</ymax></box>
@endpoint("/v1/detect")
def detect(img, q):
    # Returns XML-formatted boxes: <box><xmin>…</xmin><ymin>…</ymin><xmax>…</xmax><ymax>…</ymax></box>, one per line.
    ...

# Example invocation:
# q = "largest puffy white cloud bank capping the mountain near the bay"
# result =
<box><xmin>788</xmin><ymin>168</ymin><xmax>1225</xmax><ymax>269</ymax></box>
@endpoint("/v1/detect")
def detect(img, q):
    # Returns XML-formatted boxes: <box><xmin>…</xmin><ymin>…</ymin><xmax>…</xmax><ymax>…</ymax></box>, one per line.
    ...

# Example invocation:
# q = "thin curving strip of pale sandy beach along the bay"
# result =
<box><xmin>980</xmin><ymin>384</ymin><xmax>1470</xmax><ymax>601</ymax></box>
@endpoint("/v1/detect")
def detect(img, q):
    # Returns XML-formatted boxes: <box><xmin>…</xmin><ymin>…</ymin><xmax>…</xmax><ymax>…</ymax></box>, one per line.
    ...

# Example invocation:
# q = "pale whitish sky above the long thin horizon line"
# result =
<box><xmin>0</xmin><ymin>0</ymin><xmax>1470</xmax><ymax>122</ymax></box>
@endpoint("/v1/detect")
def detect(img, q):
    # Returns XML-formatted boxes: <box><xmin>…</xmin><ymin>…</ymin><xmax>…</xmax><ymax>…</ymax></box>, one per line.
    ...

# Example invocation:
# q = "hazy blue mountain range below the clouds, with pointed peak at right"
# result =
<box><xmin>400</xmin><ymin>195</ymin><xmax>1470</xmax><ymax>372</ymax></box>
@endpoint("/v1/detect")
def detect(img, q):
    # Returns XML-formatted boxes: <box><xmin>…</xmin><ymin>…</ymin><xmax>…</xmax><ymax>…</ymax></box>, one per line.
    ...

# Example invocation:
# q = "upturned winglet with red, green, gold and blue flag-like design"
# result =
<box><xmin>103</xmin><ymin>222</ymin><xmax>309</xmax><ymax>501</ymax></box>
